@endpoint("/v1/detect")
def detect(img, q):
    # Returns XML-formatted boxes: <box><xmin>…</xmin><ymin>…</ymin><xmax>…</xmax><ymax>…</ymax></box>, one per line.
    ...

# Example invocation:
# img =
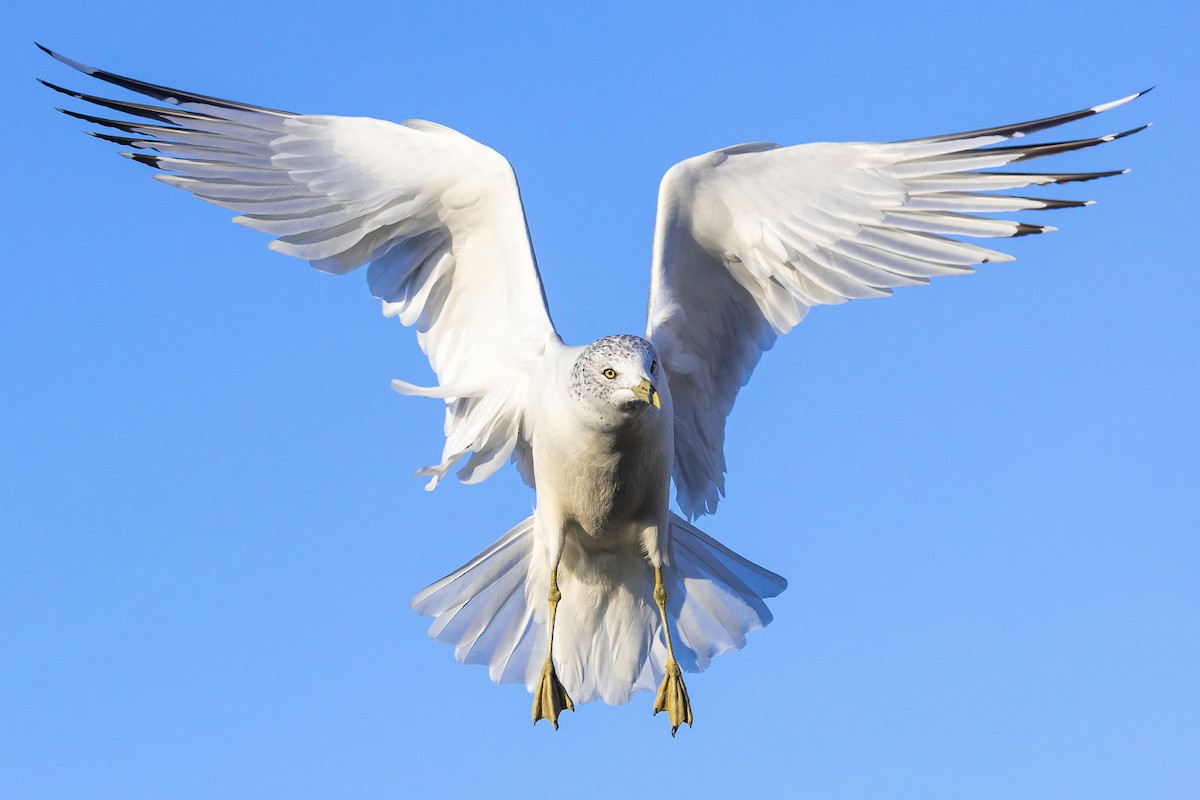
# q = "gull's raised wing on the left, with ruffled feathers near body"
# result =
<box><xmin>42</xmin><ymin>48</ymin><xmax>558</xmax><ymax>488</ymax></box>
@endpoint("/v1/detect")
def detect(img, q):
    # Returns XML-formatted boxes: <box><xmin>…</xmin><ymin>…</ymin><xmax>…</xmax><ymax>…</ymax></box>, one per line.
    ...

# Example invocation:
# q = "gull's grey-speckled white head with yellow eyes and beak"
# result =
<box><xmin>571</xmin><ymin>335</ymin><xmax>665</xmax><ymax>416</ymax></box>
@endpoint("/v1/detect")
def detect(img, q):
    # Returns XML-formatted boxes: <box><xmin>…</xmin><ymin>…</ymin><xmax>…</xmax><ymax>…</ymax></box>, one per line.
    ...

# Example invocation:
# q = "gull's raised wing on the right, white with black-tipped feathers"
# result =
<box><xmin>647</xmin><ymin>92</ymin><xmax>1145</xmax><ymax>517</ymax></box>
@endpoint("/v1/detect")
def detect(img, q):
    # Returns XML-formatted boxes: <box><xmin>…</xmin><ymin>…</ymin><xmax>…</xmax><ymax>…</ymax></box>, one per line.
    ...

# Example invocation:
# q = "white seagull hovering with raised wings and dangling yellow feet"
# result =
<box><xmin>38</xmin><ymin>44</ymin><xmax>1148</xmax><ymax>736</ymax></box>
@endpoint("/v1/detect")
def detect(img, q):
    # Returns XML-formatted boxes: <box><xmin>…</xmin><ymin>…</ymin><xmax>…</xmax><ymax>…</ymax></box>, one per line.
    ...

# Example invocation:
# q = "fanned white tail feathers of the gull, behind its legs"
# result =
<box><xmin>413</xmin><ymin>515</ymin><xmax>787</xmax><ymax>705</ymax></box>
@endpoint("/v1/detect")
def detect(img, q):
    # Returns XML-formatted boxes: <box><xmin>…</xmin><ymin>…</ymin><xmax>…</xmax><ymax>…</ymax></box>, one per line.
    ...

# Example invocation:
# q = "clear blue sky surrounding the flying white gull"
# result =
<box><xmin>0</xmin><ymin>0</ymin><xmax>1200</xmax><ymax>800</ymax></box>
